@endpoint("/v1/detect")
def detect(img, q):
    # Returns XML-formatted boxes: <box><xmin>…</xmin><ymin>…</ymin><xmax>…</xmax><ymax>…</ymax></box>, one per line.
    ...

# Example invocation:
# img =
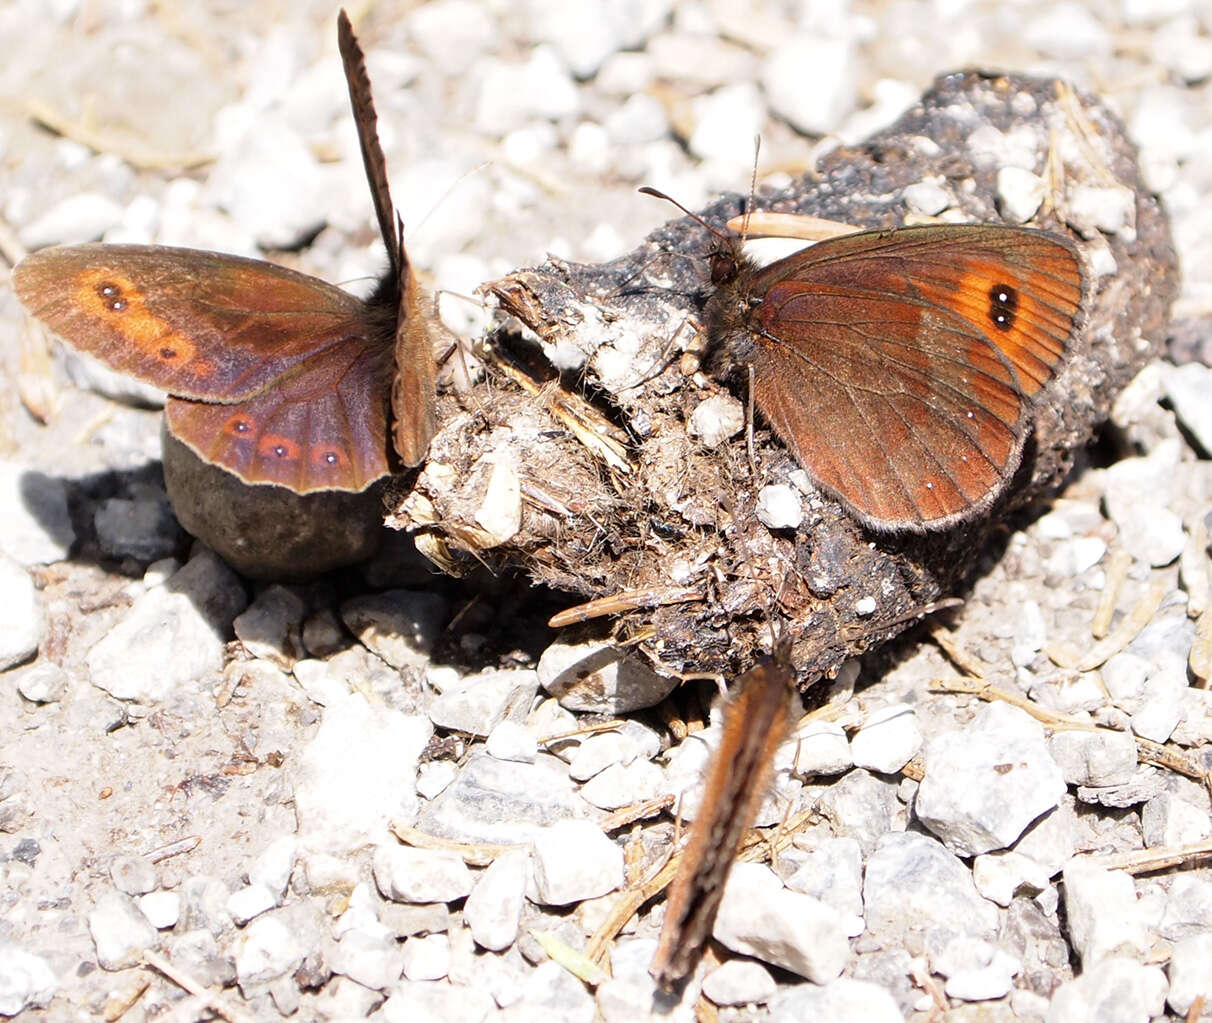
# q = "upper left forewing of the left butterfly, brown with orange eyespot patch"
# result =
<box><xmin>13</xmin><ymin>245</ymin><xmax>367</xmax><ymax>401</ymax></box>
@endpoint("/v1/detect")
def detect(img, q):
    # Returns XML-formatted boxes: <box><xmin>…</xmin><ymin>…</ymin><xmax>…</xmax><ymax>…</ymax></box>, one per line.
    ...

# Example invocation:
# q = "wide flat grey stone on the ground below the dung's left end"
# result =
<box><xmin>418</xmin><ymin>750</ymin><xmax>585</xmax><ymax>845</ymax></box>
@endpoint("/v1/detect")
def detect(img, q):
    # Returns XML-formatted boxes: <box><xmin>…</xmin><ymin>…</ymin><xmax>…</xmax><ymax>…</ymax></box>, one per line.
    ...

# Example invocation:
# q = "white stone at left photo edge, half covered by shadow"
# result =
<box><xmin>0</xmin><ymin>462</ymin><xmax>75</xmax><ymax>566</ymax></box>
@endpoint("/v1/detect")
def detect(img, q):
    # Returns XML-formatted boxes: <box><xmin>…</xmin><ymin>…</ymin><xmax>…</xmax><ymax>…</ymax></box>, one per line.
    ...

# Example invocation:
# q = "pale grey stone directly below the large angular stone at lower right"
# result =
<box><xmin>863</xmin><ymin>833</ymin><xmax>997</xmax><ymax>956</ymax></box>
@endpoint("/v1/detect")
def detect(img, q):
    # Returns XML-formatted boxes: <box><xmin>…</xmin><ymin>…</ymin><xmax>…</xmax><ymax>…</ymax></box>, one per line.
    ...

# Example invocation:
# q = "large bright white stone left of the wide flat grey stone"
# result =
<box><xmin>295</xmin><ymin>696</ymin><xmax>433</xmax><ymax>853</ymax></box>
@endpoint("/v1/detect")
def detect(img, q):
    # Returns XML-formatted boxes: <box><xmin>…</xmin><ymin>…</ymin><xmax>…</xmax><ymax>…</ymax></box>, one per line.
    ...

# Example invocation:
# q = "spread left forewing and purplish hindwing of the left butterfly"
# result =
<box><xmin>13</xmin><ymin>245</ymin><xmax>390</xmax><ymax>493</ymax></box>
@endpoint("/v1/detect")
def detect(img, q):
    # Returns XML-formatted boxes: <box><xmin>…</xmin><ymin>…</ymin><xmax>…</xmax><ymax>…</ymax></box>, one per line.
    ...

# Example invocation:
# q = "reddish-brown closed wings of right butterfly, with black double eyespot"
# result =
<box><xmin>709</xmin><ymin>225</ymin><xmax>1082</xmax><ymax>530</ymax></box>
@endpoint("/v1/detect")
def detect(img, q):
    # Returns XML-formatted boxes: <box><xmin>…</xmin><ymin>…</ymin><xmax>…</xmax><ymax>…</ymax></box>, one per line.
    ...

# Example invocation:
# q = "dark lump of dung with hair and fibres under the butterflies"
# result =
<box><xmin>390</xmin><ymin>73</ymin><xmax>1178</xmax><ymax>679</ymax></box>
